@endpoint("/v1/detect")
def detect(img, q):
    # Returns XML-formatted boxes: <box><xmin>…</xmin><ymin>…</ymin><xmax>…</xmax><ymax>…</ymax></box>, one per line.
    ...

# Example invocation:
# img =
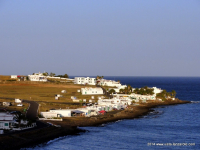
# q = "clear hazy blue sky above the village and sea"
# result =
<box><xmin>0</xmin><ymin>0</ymin><xmax>200</xmax><ymax>77</ymax></box>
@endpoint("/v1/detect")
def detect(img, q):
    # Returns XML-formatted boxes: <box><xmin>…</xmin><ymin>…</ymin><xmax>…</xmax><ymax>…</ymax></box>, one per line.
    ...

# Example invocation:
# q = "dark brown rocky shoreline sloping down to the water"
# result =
<box><xmin>0</xmin><ymin>100</ymin><xmax>191</xmax><ymax>149</ymax></box>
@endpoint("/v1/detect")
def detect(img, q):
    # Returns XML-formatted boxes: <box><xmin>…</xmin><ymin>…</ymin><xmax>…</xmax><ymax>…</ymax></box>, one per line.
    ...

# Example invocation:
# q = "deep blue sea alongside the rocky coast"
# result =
<box><xmin>26</xmin><ymin>76</ymin><xmax>200</xmax><ymax>150</ymax></box>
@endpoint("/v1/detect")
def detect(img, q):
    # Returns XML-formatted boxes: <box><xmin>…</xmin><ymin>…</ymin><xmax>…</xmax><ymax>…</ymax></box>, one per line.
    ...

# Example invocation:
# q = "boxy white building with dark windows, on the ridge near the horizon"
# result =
<box><xmin>74</xmin><ymin>77</ymin><xmax>96</xmax><ymax>85</ymax></box>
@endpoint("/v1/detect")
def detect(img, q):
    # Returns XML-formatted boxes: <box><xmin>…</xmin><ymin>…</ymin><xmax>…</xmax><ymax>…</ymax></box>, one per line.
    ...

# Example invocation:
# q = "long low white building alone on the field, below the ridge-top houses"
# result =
<box><xmin>81</xmin><ymin>87</ymin><xmax>103</xmax><ymax>95</ymax></box>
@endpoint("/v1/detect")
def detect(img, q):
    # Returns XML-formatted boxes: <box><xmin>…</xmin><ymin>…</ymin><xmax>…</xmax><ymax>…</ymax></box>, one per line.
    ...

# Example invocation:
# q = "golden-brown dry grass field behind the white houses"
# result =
<box><xmin>0</xmin><ymin>81</ymin><xmax>106</xmax><ymax>111</ymax></box>
